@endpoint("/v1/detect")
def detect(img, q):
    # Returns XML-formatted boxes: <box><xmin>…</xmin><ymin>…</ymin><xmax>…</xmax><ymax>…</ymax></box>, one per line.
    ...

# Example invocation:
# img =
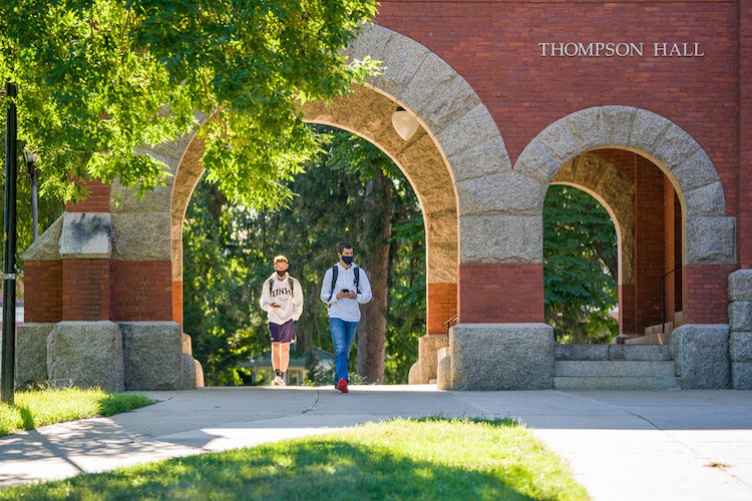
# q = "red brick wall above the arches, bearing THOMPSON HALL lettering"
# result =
<box><xmin>376</xmin><ymin>0</ymin><xmax>736</xmax><ymax>214</ymax></box>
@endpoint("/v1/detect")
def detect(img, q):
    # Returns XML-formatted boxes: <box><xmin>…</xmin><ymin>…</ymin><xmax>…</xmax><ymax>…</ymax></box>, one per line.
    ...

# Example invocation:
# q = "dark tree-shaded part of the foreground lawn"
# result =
<box><xmin>57</xmin><ymin>440</ymin><xmax>535</xmax><ymax>500</ymax></box>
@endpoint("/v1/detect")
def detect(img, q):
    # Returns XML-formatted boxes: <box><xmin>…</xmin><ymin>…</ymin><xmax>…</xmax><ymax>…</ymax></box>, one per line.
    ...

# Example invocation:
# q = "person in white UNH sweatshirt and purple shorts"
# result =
<box><xmin>259</xmin><ymin>255</ymin><xmax>303</xmax><ymax>386</ymax></box>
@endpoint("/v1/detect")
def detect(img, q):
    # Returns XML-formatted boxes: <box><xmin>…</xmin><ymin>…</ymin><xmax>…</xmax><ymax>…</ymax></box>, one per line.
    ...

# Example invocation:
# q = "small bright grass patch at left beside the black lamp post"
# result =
<box><xmin>0</xmin><ymin>388</ymin><xmax>154</xmax><ymax>436</ymax></box>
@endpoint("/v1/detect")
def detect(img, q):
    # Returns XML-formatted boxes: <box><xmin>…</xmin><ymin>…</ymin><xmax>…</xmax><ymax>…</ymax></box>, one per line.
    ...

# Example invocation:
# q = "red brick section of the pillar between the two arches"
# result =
<box><xmin>458</xmin><ymin>263</ymin><xmax>544</xmax><ymax>324</ymax></box>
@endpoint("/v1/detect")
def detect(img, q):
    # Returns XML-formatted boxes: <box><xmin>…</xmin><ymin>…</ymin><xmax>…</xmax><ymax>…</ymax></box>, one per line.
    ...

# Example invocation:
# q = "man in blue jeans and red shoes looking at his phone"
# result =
<box><xmin>321</xmin><ymin>242</ymin><xmax>372</xmax><ymax>393</ymax></box>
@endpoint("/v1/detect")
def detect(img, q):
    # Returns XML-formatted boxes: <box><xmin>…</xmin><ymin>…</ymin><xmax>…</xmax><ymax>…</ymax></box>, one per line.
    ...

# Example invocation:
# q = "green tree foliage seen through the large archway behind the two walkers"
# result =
<box><xmin>183</xmin><ymin>127</ymin><xmax>425</xmax><ymax>384</ymax></box>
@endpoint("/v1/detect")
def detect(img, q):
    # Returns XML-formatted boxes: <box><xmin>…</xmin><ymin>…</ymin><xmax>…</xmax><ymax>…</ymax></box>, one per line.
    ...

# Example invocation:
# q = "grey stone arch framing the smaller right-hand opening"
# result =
<box><xmin>515</xmin><ymin>106</ymin><xmax>736</xmax><ymax>265</ymax></box>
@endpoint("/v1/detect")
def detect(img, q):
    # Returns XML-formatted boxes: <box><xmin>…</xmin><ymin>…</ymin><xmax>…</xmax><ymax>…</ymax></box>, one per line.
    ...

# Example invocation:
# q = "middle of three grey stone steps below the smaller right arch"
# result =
<box><xmin>554</xmin><ymin>360</ymin><xmax>676</xmax><ymax>378</ymax></box>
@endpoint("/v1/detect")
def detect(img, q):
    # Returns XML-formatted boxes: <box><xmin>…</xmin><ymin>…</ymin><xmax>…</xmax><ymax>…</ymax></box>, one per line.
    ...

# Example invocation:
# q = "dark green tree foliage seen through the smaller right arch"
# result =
<box><xmin>543</xmin><ymin>185</ymin><xmax>619</xmax><ymax>343</ymax></box>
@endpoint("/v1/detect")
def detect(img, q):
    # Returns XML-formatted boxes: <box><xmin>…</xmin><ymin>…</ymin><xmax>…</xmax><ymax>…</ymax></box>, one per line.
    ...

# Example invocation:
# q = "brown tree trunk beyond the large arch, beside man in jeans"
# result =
<box><xmin>357</xmin><ymin>171</ymin><xmax>393</xmax><ymax>383</ymax></box>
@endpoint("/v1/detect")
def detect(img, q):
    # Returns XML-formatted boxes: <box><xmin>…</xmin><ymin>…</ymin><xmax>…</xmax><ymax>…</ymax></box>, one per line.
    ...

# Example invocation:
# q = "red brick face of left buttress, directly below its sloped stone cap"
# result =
<box><xmin>62</xmin><ymin>259</ymin><xmax>110</xmax><ymax>321</ymax></box>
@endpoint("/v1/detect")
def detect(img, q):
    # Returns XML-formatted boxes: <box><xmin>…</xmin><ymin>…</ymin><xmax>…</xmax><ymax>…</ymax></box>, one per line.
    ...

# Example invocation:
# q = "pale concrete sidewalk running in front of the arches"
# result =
<box><xmin>0</xmin><ymin>385</ymin><xmax>752</xmax><ymax>501</ymax></box>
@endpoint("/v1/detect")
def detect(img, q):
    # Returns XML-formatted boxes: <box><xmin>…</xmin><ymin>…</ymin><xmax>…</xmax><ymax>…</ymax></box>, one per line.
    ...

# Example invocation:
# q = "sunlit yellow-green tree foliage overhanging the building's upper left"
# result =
<box><xmin>0</xmin><ymin>0</ymin><xmax>375</xmax><ymax>207</ymax></box>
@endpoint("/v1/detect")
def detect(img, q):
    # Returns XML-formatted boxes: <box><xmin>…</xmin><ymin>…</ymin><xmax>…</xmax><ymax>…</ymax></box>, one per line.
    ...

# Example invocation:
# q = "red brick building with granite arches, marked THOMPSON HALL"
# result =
<box><xmin>19</xmin><ymin>0</ymin><xmax>752</xmax><ymax>389</ymax></box>
